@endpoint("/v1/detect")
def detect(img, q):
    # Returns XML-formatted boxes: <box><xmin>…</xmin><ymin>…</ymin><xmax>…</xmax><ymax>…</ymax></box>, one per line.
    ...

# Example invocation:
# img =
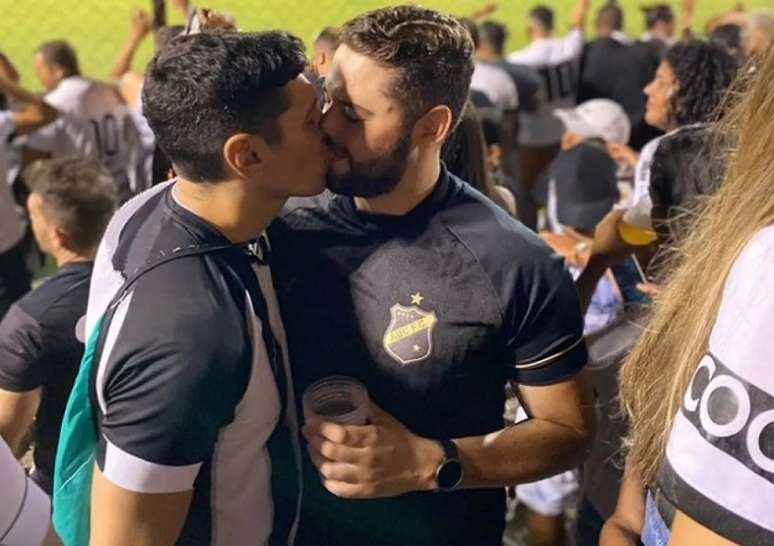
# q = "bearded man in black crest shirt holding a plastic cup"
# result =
<box><xmin>271</xmin><ymin>6</ymin><xmax>593</xmax><ymax>546</ymax></box>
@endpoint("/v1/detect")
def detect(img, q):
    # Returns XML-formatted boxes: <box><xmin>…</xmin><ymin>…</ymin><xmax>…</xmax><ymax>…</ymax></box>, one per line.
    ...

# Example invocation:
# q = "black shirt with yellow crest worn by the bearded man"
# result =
<box><xmin>270</xmin><ymin>170</ymin><xmax>586</xmax><ymax>546</ymax></box>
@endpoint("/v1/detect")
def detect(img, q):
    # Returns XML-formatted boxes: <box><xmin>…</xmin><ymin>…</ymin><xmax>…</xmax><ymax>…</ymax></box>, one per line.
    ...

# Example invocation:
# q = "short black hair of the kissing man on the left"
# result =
<box><xmin>142</xmin><ymin>32</ymin><xmax>306</xmax><ymax>182</ymax></box>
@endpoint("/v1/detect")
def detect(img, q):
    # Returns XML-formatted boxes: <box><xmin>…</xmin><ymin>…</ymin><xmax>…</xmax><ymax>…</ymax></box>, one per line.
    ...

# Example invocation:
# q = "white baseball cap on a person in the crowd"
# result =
<box><xmin>554</xmin><ymin>99</ymin><xmax>632</xmax><ymax>144</ymax></box>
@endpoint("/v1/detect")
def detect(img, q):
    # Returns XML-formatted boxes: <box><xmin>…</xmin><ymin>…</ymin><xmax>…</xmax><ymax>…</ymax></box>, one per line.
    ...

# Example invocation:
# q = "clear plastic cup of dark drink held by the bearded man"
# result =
<box><xmin>302</xmin><ymin>375</ymin><xmax>368</xmax><ymax>425</ymax></box>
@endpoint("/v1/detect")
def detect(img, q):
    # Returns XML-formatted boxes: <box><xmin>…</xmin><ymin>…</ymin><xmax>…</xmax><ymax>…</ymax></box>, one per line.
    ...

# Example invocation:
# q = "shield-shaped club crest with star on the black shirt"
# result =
<box><xmin>383</xmin><ymin>293</ymin><xmax>438</xmax><ymax>366</ymax></box>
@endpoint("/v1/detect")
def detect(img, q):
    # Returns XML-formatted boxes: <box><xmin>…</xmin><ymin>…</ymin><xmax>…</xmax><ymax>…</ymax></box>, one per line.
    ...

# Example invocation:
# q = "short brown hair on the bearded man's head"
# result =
<box><xmin>341</xmin><ymin>6</ymin><xmax>474</xmax><ymax>130</ymax></box>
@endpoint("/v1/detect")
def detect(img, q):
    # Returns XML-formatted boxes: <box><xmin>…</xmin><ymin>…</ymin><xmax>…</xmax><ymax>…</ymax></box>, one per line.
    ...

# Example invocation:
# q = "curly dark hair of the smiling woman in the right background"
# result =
<box><xmin>664</xmin><ymin>40</ymin><xmax>738</xmax><ymax>127</ymax></box>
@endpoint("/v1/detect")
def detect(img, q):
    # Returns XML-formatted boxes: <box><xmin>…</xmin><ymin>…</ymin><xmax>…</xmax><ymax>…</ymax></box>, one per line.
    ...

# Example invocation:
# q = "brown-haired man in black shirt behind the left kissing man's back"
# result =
<box><xmin>0</xmin><ymin>158</ymin><xmax>117</xmax><ymax>495</ymax></box>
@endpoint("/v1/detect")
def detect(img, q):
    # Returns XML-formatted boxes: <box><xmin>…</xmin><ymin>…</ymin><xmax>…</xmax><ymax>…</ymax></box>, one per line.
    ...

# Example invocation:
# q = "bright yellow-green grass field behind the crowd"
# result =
<box><xmin>0</xmin><ymin>0</ymin><xmax>774</xmax><ymax>89</ymax></box>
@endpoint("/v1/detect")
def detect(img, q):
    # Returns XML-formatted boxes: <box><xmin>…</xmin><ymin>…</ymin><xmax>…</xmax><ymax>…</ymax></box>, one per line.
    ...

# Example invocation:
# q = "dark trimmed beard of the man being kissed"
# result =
<box><xmin>326</xmin><ymin>130</ymin><xmax>411</xmax><ymax>198</ymax></box>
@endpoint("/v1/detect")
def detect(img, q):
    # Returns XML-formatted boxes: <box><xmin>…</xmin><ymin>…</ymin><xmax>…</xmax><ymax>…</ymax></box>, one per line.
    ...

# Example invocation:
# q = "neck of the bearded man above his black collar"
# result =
<box><xmin>355</xmin><ymin>153</ymin><xmax>441</xmax><ymax>216</ymax></box>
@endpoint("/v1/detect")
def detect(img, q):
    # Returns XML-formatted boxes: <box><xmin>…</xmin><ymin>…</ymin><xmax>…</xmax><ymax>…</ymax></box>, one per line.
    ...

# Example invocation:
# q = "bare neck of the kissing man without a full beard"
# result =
<box><xmin>173</xmin><ymin>178</ymin><xmax>287</xmax><ymax>243</ymax></box>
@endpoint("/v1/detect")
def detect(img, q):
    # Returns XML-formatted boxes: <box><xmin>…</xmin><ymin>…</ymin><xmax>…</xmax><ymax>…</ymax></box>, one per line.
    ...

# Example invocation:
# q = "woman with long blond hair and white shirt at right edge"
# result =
<box><xmin>601</xmin><ymin>43</ymin><xmax>774</xmax><ymax>546</ymax></box>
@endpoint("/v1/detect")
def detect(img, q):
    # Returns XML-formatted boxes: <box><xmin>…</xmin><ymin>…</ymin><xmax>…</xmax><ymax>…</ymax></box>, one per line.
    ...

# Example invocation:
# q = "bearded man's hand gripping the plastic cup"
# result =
<box><xmin>303</xmin><ymin>402</ymin><xmax>444</xmax><ymax>498</ymax></box>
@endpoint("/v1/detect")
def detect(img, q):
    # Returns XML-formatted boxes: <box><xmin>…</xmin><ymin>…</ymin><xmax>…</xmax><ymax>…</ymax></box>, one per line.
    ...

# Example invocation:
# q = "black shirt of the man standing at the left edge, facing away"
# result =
<box><xmin>0</xmin><ymin>262</ymin><xmax>92</xmax><ymax>494</ymax></box>
